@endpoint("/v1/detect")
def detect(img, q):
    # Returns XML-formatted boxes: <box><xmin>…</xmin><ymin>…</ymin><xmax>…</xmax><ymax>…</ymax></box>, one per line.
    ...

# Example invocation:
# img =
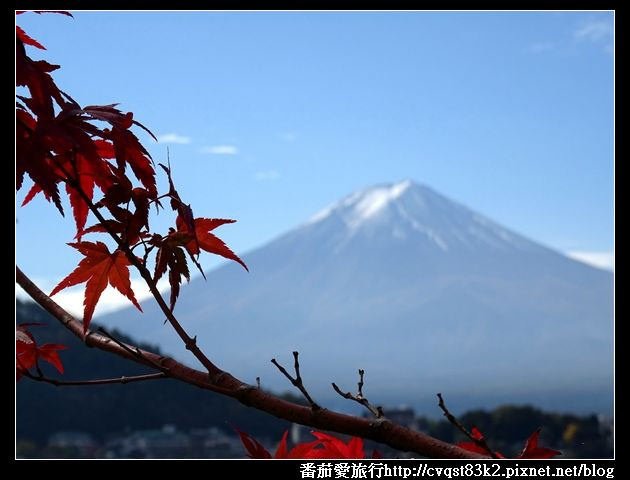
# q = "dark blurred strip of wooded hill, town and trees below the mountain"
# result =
<box><xmin>16</xmin><ymin>301</ymin><xmax>612</xmax><ymax>458</ymax></box>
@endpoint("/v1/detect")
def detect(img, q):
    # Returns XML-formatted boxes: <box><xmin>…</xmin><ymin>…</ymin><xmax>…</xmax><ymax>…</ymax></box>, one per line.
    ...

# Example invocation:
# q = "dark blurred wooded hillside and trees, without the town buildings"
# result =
<box><xmin>16</xmin><ymin>300</ymin><xmax>613</xmax><ymax>458</ymax></box>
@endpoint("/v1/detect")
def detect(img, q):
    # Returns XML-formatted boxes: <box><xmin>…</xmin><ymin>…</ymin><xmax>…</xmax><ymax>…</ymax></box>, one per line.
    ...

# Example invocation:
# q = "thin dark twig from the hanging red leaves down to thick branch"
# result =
<box><xmin>67</xmin><ymin>177</ymin><xmax>223</xmax><ymax>380</ymax></box>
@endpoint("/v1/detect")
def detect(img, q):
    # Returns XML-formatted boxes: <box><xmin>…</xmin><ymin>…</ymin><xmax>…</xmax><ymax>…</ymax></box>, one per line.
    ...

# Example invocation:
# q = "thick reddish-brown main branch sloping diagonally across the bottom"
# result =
<box><xmin>15</xmin><ymin>267</ymin><xmax>487</xmax><ymax>458</ymax></box>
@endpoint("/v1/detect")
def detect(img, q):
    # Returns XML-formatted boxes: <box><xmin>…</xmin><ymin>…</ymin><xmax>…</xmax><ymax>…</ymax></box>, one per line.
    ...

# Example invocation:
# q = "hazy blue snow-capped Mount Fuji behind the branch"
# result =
<box><xmin>100</xmin><ymin>181</ymin><xmax>613</xmax><ymax>412</ymax></box>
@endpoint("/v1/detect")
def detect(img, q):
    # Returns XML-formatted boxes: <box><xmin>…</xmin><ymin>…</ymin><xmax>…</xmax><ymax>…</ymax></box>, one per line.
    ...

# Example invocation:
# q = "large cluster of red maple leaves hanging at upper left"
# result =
<box><xmin>16</xmin><ymin>11</ymin><xmax>247</xmax><ymax>330</ymax></box>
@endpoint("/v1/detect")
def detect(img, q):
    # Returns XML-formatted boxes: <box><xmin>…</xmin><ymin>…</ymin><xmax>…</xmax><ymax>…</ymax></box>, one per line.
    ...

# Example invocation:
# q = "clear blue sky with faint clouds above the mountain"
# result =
<box><xmin>16</xmin><ymin>12</ymin><xmax>614</xmax><ymax>316</ymax></box>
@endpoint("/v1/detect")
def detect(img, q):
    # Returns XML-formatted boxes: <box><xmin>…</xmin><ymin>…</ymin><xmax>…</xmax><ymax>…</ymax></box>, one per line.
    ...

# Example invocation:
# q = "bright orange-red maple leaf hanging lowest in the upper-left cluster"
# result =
<box><xmin>50</xmin><ymin>242</ymin><xmax>142</xmax><ymax>331</ymax></box>
